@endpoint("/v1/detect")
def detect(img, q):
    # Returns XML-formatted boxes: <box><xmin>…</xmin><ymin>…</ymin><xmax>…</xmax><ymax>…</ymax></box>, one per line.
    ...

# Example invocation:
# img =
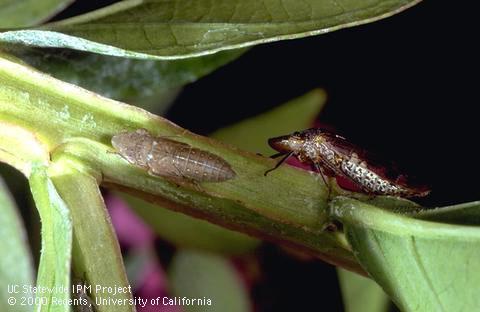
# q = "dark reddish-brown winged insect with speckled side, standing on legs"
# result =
<box><xmin>265</xmin><ymin>128</ymin><xmax>430</xmax><ymax>197</ymax></box>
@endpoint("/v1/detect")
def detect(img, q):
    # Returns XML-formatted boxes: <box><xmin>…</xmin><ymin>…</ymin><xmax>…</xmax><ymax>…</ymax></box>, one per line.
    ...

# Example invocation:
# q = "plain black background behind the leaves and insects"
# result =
<box><xmin>53</xmin><ymin>0</ymin><xmax>480</xmax><ymax>311</ymax></box>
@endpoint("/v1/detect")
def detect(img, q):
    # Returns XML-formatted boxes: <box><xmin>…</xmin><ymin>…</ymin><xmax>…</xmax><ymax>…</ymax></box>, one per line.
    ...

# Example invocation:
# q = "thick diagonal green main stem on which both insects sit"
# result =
<box><xmin>0</xmin><ymin>51</ymin><xmax>362</xmax><ymax>271</ymax></box>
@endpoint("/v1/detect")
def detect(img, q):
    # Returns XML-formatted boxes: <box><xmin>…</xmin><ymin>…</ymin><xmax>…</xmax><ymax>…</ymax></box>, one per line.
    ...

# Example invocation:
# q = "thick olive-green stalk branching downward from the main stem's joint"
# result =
<box><xmin>48</xmin><ymin>155</ymin><xmax>132</xmax><ymax>312</ymax></box>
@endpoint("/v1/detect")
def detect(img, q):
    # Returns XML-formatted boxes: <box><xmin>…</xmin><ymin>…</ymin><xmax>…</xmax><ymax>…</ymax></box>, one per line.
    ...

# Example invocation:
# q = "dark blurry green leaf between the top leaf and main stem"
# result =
<box><xmin>12</xmin><ymin>48</ymin><xmax>245</xmax><ymax>106</ymax></box>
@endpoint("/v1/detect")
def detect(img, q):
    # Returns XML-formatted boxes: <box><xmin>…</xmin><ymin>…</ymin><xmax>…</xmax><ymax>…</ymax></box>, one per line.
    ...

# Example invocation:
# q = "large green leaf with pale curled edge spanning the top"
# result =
<box><xmin>0</xmin><ymin>0</ymin><xmax>419</xmax><ymax>59</ymax></box>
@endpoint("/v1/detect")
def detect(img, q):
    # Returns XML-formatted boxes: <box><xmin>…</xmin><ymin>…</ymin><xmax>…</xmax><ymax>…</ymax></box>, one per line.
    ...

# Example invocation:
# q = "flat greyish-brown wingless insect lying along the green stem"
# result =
<box><xmin>112</xmin><ymin>129</ymin><xmax>236</xmax><ymax>182</ymax></box>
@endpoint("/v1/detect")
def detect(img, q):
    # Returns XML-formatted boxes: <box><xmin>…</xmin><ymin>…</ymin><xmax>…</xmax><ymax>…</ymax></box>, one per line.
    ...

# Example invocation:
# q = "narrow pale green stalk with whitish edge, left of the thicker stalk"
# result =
<box><xmin>29</xmin><ymin>165</ymin><xmax>72</xmax><ymax>312</ymax></box>
